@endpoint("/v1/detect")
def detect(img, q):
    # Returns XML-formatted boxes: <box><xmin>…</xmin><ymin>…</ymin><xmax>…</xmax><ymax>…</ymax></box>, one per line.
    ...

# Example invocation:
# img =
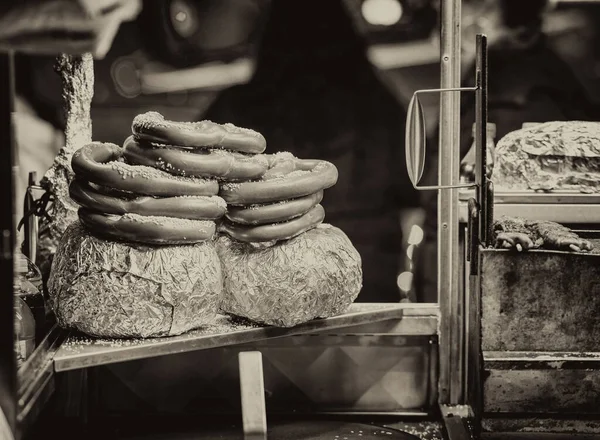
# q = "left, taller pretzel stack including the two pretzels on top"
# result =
<box><xmin>70</xmin><ymin>112</ymin><xmax>268</xmax><ymax>244</ymax></box>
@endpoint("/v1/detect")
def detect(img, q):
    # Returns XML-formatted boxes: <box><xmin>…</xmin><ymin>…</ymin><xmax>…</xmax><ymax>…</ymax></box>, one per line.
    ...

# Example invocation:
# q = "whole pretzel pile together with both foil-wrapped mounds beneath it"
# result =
<box><xmin>49</xmin><ymin>112</ymin><xmax>362</xmax><ymax>337</ymax></box>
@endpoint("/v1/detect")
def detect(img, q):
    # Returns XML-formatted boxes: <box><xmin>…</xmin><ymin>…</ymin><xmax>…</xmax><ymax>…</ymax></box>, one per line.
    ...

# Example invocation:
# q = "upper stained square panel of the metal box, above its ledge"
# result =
<box><xmin>481</xmin><ymin>237</ymin><xmax>600</xmax><ymax>352</ymax></box>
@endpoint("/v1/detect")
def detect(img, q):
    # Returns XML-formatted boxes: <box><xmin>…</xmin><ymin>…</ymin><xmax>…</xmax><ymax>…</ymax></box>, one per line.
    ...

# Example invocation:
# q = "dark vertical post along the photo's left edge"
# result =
<box><xmin>0</xmin><ymin>53</ymin><xmax>18</xmax><ymax>432</ymax></box>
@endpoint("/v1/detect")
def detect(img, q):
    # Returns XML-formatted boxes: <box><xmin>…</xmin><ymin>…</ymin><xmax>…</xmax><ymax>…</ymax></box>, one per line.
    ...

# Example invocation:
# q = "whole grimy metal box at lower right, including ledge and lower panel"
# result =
<box><xmin>481</xmin><ymin>232</ymin><xmax>600</xmax><ymax>418</ymax></box>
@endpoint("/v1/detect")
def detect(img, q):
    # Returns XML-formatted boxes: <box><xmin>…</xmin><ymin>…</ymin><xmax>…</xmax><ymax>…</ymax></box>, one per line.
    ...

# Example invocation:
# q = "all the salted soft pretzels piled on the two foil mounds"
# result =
<box><xmin>70</xmin><ymin>112</ymin><xmax>338</xmax><ymax>244</ymax></box>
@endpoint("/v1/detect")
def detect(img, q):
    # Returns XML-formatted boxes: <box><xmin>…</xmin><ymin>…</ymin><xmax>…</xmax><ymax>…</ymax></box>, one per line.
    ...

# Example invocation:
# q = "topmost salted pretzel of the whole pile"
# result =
<box><xmin>131</xmin><ymin>112</ymin><xmax>267</xmax><ymax>154</ymax></box>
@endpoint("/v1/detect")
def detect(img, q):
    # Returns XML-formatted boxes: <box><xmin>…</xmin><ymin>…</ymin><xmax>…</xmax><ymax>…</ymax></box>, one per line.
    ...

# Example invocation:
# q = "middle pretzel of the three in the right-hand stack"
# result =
<box><xmin>225</xmin><ymin>191</ymin><xmax>323</xmax><ymax>225</ymax></box>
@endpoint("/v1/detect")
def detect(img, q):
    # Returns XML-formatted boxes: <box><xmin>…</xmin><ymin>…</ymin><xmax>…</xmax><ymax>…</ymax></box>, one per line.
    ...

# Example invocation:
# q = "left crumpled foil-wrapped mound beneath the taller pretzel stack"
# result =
<box><xmin>48</xmin><ymin>222</ymin><xmax>223</xmax><ymax>338</ymax></box>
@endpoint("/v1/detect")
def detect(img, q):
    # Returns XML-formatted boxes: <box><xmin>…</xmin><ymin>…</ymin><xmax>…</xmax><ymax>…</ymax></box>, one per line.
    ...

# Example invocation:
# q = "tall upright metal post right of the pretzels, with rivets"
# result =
<box><xmin>438</xmin><ymin>0</ymin><xmax>464</xmax><ymax>404</ymax></box>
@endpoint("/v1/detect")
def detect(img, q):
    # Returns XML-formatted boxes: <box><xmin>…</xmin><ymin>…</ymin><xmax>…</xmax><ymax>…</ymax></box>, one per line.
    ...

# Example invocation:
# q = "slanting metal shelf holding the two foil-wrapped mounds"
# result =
<box><xmin>54</xmin><ymin>303</ymin><xmax>438</xmax><ymax>372</ymax></box>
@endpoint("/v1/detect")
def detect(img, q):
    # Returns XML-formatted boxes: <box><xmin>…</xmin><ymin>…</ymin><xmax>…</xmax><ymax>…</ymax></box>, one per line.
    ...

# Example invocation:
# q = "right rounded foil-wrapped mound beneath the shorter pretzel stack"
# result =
<box><xmin>217</xmin><ymin>224</ymin><xmax>362</xmax><ymax>327</ymax></box>
